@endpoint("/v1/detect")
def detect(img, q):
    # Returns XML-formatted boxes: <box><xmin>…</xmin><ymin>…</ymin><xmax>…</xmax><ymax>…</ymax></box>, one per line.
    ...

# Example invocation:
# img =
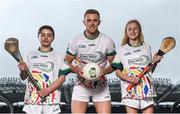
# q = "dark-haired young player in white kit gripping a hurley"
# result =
<box><xmin>18</xmin><ymin>25</ymin><xmax>65</xmax><ymax>114</ymax></box>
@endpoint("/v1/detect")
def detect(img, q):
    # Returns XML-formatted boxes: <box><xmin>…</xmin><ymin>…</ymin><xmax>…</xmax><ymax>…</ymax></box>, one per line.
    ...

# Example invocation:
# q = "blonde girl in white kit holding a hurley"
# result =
<box><xmin>112</xmin><ymin>20</ymin><xmax>161</xmax><ymax>113</ymax></box>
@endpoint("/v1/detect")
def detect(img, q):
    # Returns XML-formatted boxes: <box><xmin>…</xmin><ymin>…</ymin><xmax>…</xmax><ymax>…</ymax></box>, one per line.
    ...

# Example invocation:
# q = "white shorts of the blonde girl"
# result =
<box><xmin>121</xmin><ymin>98</ymin><xmax>155</xmax><ymax>109</ymax></box>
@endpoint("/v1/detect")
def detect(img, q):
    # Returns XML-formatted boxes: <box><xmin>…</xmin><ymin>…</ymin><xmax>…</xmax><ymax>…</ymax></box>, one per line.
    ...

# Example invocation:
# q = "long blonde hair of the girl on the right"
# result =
<box><xmin>121</xmin><ymin>19</ymin><xmax>144</xmax><ymax>46</ymax></box>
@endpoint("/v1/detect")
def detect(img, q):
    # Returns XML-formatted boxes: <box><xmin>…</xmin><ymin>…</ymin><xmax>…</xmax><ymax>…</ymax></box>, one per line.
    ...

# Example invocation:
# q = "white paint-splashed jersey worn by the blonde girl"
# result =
<box><xmin>112</xmin><ymin>43</ymin><xmax>155</xmax><ymax>99</ymax></box>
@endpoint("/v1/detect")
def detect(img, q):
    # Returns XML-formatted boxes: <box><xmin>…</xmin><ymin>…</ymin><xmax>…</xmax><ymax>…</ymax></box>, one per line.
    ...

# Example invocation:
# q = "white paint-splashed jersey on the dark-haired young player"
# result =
<box><xmin>24</xmin><ymin>50</ymin><xmax>63</xmax><ymax>104</ymax></box>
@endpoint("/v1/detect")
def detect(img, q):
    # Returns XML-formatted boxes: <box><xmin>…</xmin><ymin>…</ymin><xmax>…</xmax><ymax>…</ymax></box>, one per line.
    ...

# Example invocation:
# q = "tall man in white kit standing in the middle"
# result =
<box><xmin>65</xmin><ymin>9</ymin><xmax>116</xmax><ymax>113</ymax></box>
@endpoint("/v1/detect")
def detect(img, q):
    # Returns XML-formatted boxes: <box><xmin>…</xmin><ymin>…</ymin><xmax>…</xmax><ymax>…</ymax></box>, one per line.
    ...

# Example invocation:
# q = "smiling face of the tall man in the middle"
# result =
<box><xmin>83</xmin><ymin>14</ymin><xmax>100</xmax><ymax>34</ymax></box>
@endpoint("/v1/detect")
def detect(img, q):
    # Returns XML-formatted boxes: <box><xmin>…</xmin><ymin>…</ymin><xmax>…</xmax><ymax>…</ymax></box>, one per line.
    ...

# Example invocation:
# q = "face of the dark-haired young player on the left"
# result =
<box><xmin>39</xmin><ymin>29</ymin><xmax>54</xmax><ymax>47</ymax></box>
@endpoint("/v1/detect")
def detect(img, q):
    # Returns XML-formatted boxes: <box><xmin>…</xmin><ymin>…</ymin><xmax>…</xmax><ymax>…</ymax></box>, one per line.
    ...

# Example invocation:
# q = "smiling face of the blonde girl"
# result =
<box><xmin>126</xmin><ymin>22</ymin><xmax>140</xmax><ymax>40</ymax></box>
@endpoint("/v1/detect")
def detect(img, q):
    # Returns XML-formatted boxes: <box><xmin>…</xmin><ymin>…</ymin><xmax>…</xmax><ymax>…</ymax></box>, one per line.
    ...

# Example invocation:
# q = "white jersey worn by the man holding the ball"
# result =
<box><xmin>67</xmin><ymin>33</ymin><xmax>116</xmax><ymax>88</ymax></box>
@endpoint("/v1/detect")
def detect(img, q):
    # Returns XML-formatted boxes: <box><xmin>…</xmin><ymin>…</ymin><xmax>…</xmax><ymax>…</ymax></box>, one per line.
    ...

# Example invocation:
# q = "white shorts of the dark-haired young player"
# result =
<box><xmin>23</xmin><ymin>104</ymin><xmax>61</xmax><ymax>114</ymax></box>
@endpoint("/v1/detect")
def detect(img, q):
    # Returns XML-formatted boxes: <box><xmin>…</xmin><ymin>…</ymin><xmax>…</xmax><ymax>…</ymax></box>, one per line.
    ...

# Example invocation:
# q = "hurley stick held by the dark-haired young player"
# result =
<box><xmin>4</xmin><ymin>38</ymin><xmax>46</xmax><ymax>102</ymax></box>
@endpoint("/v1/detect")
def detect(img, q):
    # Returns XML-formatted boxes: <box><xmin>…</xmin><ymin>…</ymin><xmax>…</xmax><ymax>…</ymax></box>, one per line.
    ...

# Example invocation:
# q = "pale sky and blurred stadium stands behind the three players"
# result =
<box><xmin>0</xmin><ymin>0</ymin><xmax>180</xmax><ymax>112</ymax></box>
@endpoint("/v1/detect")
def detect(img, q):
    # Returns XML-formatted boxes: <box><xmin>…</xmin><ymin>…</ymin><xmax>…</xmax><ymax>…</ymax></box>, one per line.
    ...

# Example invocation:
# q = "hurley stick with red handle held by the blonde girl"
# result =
<box><xmin>126</xmin><ymin>37</ymin><xmax>176</xmax><ymax>93</ymax></box>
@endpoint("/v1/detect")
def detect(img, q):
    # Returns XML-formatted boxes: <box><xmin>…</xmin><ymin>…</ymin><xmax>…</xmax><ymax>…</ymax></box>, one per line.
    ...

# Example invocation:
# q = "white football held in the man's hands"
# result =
<box><xmin>83</xmin><ymin>63</ymin><xmax>100</xmax><ymax>81</ymax></box>
